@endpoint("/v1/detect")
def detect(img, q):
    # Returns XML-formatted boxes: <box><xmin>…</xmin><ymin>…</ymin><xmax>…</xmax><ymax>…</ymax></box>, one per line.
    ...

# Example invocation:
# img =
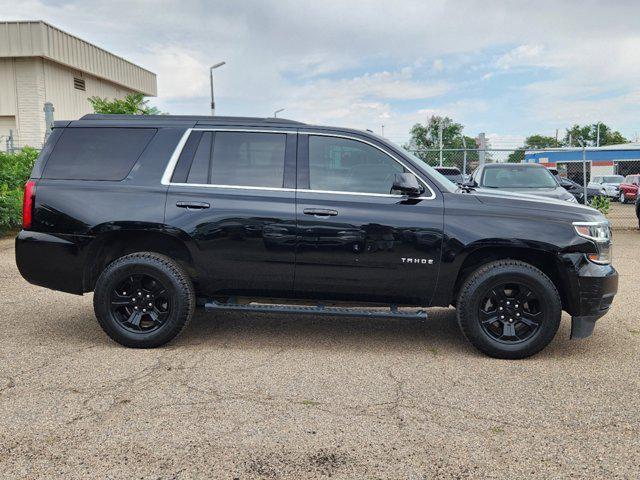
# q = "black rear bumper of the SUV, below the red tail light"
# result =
<box><xmin>16</xmin><ymin>230</ymin><xmax>91</xmax><ymax>295</ymax></box>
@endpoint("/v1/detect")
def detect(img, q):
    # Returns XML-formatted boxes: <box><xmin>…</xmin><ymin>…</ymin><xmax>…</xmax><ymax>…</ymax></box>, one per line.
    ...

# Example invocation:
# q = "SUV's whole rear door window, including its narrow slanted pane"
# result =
<box><xmin>171</xmin><ymin>131</ymin><xmax>287</xmax><ymax>188</ymax></box>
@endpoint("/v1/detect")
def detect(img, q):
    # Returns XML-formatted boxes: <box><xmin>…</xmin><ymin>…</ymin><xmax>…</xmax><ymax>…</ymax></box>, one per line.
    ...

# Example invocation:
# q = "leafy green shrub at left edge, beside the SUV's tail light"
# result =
<box><xmin>0</xmin><ymin>147</ymin><xmax>38</xmax><ymax>233</ymax></box>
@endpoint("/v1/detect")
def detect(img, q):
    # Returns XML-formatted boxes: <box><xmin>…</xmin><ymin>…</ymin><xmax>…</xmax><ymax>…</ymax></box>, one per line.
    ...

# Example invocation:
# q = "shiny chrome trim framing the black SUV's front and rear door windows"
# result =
<box><xmin>160</xmin><ymin>127</ymin><xmax>436</xmax><ymax>200</ymax></box>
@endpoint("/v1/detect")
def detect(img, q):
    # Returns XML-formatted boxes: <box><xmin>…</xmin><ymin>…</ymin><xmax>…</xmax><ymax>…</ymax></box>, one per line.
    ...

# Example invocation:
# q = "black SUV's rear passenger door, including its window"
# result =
<box><xmin>163</xmin><ymin>128</ymin><xmax>296</xmax><ymax>296</ymax></box>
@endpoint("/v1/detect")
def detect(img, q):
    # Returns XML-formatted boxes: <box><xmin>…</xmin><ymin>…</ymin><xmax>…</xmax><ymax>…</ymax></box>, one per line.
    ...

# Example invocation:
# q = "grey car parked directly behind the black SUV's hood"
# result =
<box><xmin>472</xmin><ymin>163</ymin><xmax>577</xmax><ymax>202</ymax></box>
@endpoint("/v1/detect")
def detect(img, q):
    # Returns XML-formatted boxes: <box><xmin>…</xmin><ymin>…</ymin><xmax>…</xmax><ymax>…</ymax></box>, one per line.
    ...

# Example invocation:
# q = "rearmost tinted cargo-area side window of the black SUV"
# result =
<box><xmin>43</xmin><ymin>128</ymin><xmax>156</xmax><ymax>180</ymax></box>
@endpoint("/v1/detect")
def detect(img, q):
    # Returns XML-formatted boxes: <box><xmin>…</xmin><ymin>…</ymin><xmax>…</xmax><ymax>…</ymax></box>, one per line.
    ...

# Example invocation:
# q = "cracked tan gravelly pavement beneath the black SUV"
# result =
<box><xmin>0</xmin><ymin>232</ymin><xmax>640</xmax><ymax>479</ymax></box>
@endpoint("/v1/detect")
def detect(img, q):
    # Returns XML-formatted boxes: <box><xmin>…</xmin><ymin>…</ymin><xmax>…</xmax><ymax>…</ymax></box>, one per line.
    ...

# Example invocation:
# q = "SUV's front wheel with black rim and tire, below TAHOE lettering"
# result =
<box><xmin>457</xmin><ymin>260</ymin><xmax>562</xmax><ymax>359</ymax></box>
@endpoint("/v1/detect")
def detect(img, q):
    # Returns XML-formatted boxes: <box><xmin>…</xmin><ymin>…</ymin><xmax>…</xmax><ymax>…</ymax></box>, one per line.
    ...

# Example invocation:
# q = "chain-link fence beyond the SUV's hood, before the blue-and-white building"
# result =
<box><xmin>412</xmin><ymin>145</ymin><xmax>640</xmax><ymax>229</ymax></box>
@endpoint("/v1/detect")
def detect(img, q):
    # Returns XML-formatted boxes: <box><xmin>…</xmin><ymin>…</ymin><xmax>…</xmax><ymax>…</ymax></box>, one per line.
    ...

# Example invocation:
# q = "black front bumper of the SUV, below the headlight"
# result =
<box><xmin>563</xmin><ymin>253</ymin><xmax>618</xmax><ymax>338</ymax></box>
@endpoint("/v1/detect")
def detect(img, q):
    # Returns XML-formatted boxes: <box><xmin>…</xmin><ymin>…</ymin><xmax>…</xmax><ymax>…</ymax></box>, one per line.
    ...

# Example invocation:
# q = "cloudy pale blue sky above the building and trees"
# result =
<box><xmin>0</xmin><ymin>0</ymin><xmax>640</xmax><ymax>148</ymax></box>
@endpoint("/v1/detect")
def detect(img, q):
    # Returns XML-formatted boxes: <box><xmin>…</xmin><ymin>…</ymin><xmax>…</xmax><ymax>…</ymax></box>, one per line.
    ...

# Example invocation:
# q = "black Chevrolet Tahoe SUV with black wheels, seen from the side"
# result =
<box><xmin>16</xmin><ymin>115</ymin><xmax>618</xmax><ymax>358</ymax></box>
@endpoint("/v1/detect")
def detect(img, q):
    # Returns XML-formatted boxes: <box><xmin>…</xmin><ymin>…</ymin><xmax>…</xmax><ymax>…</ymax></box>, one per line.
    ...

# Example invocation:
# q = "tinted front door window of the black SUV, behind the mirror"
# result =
<box><xmin>309</xmin><ymin>136</ymin><xmax>405</xmax><ymax>194</ymax></box>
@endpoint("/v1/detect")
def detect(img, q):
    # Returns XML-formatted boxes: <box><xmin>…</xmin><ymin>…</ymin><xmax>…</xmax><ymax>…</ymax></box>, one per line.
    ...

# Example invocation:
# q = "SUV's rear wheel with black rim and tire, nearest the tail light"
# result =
<box><xmin>93</xmin><ymin>252</ymin><xmax>196</xmax><ymax>348</ymax></box>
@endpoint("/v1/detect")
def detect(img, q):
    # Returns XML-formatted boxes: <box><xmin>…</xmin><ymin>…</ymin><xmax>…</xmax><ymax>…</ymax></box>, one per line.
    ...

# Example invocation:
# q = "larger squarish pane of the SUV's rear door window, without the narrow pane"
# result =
<box><xmin>210</xmin><ymin>132</ymin><xmax>286</xmax><ymax>188</ymax></box>
